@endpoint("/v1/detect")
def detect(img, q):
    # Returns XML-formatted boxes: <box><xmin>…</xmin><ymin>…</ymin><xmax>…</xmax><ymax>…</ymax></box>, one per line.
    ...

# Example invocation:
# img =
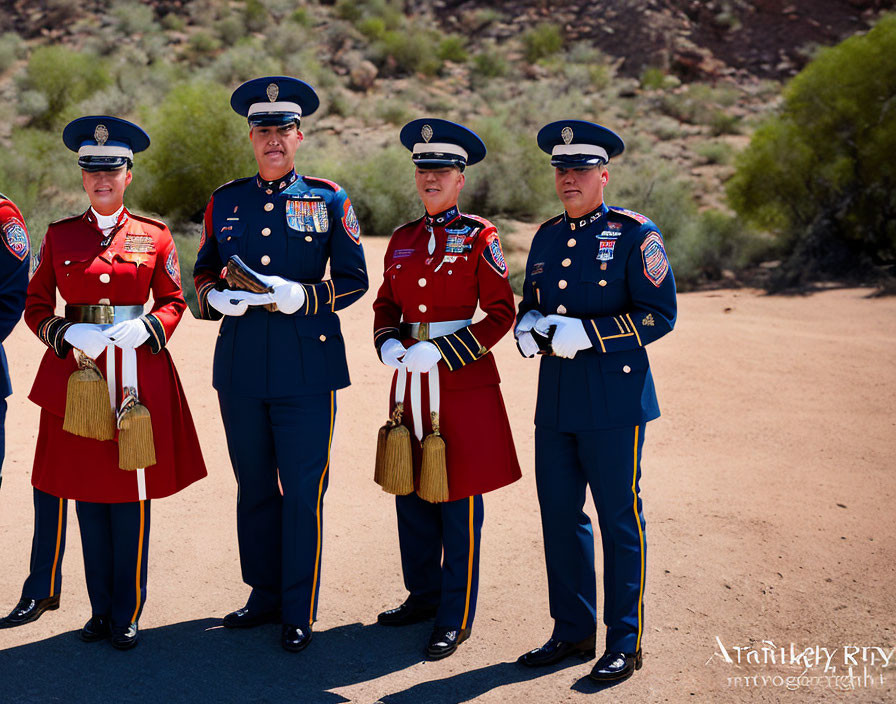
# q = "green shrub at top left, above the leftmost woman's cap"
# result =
<box><xmin>23</xmin><ymin>46</ymin><xmax>111</xmax><ymax>129</ymax></box>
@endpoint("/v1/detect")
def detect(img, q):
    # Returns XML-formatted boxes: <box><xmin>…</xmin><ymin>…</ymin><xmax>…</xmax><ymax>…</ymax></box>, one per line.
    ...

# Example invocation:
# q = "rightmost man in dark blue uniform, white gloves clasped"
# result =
<box><xmin>515</xmin><ymin>120</ymin><xmax>676</xmax><ymax>682</ymax></box>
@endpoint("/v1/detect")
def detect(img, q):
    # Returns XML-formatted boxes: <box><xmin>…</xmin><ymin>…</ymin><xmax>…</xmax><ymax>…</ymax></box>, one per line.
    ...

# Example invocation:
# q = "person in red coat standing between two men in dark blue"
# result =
<box><xmin>373</xmin><ymin>118</ymin><xmax>520</xmax><ymax>659</ymax></box>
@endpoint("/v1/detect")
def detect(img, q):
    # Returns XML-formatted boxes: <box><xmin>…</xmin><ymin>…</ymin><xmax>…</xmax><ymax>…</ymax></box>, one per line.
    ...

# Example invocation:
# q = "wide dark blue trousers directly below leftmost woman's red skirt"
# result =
<box><xmin>75</xmin><ymin>501</ymin><xmax>150</xmax><ymax>628</ymax></box>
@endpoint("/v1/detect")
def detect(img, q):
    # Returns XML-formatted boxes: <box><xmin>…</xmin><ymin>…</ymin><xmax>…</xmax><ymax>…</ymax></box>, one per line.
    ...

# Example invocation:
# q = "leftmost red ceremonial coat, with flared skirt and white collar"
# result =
<box><xmin>25</xmin><ymin>209</ymin><xmax>206</xmax><ymax>503</ymax></box>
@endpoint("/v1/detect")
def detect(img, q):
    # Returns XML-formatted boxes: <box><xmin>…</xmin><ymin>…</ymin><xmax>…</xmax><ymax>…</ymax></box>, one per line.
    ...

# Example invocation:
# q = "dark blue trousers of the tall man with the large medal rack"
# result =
<box><xmin>218</xmin><ymin>391</ymin><xmax>336</xmax><ymax>625</ymax></box>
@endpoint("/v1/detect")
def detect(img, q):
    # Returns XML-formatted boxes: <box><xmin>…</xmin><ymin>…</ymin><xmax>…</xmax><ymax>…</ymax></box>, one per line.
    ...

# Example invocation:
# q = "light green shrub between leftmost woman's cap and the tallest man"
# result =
<box><xmin>132</xmin><ymin>82</ymin><xmax>256</xmax><ymax>218</ymax></box>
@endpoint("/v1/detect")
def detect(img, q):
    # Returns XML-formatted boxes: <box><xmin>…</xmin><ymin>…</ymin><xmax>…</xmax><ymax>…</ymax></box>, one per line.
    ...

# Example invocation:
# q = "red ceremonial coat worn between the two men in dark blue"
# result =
<box><xmin>373</xmin><ymin>206</ymin><xmax>520</xmax><ymax>501</ymax></box>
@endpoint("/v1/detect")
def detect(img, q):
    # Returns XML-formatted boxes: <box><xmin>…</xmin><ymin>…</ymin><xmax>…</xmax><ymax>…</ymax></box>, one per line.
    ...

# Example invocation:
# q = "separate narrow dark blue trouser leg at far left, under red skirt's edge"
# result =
<box><xmin>22</xmin><ymin>489</ymin><xmax>68</xmax><ymax>599</ymax></box>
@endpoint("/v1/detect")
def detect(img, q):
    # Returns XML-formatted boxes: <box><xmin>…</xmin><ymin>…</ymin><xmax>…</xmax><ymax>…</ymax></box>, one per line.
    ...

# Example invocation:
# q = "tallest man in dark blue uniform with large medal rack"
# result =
<box><xmin>193</xmin><ymin>76</ymin><xmax>368</xmax><ymax>652</ymax></box>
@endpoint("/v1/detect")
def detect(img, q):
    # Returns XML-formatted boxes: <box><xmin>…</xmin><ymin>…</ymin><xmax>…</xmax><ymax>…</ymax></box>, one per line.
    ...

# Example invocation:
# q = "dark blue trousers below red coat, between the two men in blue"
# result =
<box><xmin>395</xmin><ymin>493</ymin><xmax>484</xmax><ymax>630</ymax></box>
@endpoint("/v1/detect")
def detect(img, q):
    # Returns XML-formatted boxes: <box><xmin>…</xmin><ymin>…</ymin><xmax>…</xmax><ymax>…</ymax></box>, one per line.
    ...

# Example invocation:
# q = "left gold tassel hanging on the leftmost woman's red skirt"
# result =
<box><xmin>62</xmin><ymin>349</ymin><xmax>115</xmax><ymax>440</ymax></box>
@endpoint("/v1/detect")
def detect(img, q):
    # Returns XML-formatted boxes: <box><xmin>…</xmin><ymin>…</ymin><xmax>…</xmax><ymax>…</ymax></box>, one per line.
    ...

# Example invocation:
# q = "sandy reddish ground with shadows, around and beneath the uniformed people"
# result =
<box><xmin>0</xmin><ymin>240</ymin><xmax>896</xmax><ymax>704</ymax></box>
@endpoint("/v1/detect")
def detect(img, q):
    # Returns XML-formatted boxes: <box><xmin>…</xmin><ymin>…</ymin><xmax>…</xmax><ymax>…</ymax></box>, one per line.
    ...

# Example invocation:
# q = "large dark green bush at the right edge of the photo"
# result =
<box><xmin>727</xmin><ymin>15</ymin><xmax>896</xmax><ymax>285</ymax></box>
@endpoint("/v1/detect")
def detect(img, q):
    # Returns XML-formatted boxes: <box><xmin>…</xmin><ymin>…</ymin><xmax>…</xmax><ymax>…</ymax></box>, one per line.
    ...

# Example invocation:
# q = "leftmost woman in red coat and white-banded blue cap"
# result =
<box><xmin>0</xmin><ymin>116</ymin><xmax>206</xmax><ymax>650</ymax></box>
